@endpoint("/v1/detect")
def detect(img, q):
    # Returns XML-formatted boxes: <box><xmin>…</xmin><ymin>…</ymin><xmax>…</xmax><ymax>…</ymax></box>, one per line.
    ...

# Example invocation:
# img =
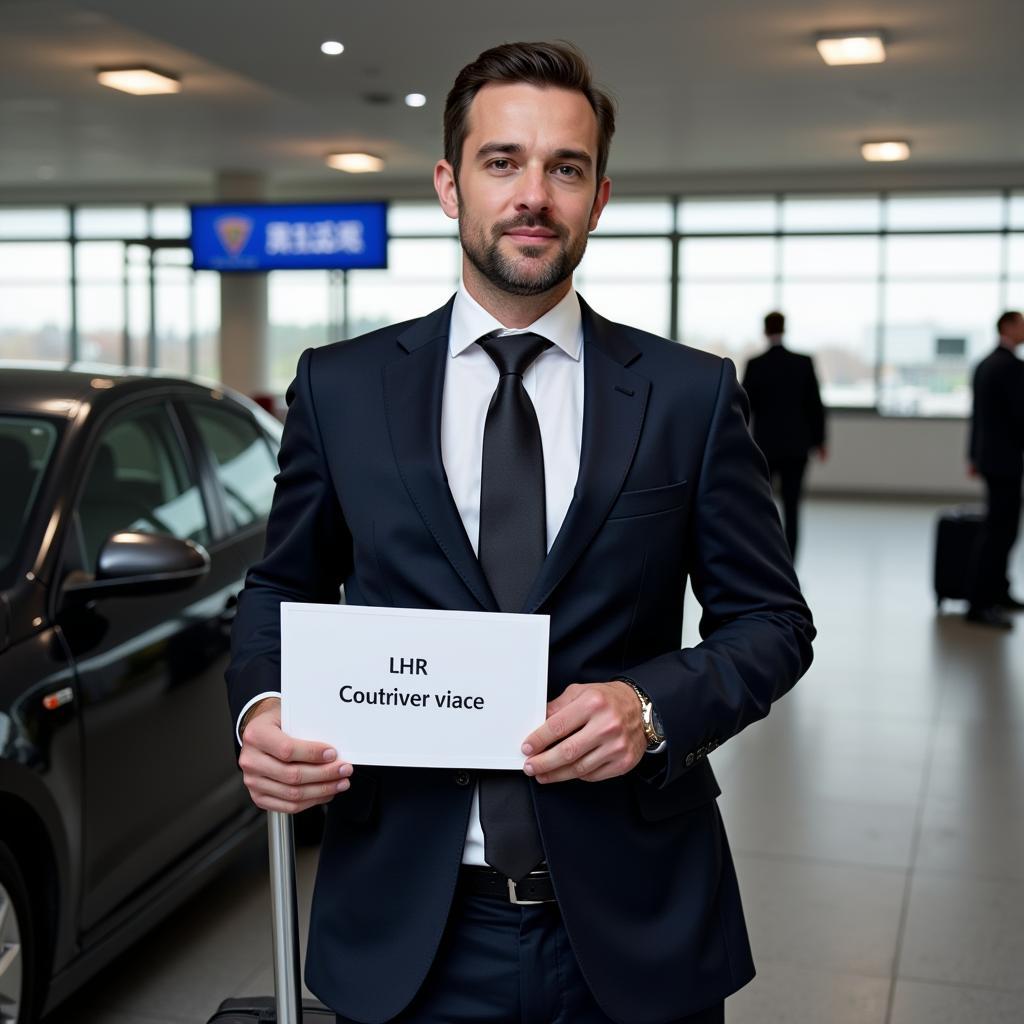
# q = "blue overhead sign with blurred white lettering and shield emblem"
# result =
<box><xmin>191</xmin><ymin>203</ymin><xmax>387</xmax><ymax>270</ymax></box>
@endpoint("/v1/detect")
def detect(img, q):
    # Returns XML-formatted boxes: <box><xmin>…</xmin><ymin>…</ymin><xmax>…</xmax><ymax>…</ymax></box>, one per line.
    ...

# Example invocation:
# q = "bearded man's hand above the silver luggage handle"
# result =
<box><xmin>239</xmin><ymin>697</ymin><xmax>352</xmax><ymax>814</ymax></box>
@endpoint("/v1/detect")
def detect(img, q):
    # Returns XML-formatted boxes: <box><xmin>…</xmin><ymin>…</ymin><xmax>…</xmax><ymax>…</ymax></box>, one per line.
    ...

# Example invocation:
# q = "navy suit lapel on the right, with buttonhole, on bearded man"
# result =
<box><xmin>522</xmin><ymin>299</ymin><xmax>650</xmax><ymax>613</ymax></box>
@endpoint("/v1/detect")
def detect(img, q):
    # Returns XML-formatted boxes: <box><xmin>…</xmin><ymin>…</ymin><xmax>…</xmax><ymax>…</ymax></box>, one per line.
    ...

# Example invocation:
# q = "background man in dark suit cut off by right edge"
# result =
<box><xmin>966</xmin><ymin>311</ymin><xmax>1024</xmax><ymax>630</ymax></box>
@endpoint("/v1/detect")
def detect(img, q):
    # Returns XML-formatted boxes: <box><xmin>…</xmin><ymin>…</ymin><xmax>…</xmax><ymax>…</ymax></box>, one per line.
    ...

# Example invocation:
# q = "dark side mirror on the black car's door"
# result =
<box><xmin>65</xmin><ymin>531</ymin><xmax>210</xmax><ymax>599</ymax></box>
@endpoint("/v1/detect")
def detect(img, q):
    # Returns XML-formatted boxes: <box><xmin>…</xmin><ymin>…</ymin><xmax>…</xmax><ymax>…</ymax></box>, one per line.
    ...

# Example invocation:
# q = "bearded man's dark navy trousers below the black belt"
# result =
<box><xmin>338</xmin><ymin>894</ymin><xmax>725</xmax><ymax>1024</ymax></box>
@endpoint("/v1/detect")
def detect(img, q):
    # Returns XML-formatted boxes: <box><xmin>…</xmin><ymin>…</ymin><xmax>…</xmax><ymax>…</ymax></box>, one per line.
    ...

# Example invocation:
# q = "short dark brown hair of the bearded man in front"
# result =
<box><xmin>444</xmin><ymin>43</ymin><xmax>615</xmax><ymax>184</ymax></box>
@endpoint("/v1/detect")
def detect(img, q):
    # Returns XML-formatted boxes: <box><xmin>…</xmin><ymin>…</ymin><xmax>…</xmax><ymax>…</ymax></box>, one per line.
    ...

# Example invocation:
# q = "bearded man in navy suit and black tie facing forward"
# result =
<box><xmin>228</xmin><ymin>43</ymin><xmax>814</xmax><ymax>1024</ymax></box>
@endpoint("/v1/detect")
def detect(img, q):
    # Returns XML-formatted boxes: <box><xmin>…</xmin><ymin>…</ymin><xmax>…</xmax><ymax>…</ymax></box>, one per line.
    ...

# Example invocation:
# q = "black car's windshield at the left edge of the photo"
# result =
<box><xmin>0</xmin><ymin>416</ymin><xmax>57</xmax><ymax>588</ymax></box>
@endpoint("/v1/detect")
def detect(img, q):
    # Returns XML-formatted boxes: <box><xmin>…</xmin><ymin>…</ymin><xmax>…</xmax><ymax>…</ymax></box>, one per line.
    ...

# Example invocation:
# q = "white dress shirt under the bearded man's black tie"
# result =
<box><xmin>441</xmin><ymin>287</ymin><xmax>584</xmax><ymax>865</ymax></box>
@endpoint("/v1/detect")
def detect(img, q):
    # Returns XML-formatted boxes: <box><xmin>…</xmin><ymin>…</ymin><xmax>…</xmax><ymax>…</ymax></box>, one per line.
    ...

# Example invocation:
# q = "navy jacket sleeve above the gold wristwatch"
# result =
<box><xmin>627</xmin><ymin>360</ymin><xmax>815</xmax><ymax>785</ymax></box>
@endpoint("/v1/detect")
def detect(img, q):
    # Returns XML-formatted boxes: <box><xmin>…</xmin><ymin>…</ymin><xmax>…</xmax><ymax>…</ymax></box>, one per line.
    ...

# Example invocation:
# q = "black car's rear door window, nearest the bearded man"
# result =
<box><xmin>189</xmin><ymin>403</ymin><xmax>278</xmax><ymax>529</ymax></box>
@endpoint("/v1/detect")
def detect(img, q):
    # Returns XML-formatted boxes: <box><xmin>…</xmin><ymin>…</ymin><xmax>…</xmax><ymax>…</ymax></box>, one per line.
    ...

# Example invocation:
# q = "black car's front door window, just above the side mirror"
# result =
<box><xmin>78</xmin><ymin>404</ymin><xmax>210</xmax><ymax>570</ymax></box>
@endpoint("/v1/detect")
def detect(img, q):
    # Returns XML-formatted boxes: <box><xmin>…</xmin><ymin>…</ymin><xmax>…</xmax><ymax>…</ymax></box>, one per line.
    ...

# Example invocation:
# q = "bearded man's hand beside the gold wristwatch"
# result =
<box><xmin>522</xmin><ymin>680</ymin><xmax>647</xmax><ymax>782</ymax></box>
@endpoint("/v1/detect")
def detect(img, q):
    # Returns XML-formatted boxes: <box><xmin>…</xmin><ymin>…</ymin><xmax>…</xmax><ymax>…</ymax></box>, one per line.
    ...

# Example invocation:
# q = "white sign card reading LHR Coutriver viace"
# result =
<box><xmin>281</xmin><ymin>602</ymin><xmax>550</xmax><ymax>769</ymax></box>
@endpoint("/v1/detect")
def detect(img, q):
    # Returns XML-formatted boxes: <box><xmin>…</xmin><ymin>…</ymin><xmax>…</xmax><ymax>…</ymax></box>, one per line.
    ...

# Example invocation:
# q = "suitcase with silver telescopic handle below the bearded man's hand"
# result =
<box><xmin>209</xmin><ymin>811</ymin><xmax>335</xmax><ymax>1024</ymax></box>
